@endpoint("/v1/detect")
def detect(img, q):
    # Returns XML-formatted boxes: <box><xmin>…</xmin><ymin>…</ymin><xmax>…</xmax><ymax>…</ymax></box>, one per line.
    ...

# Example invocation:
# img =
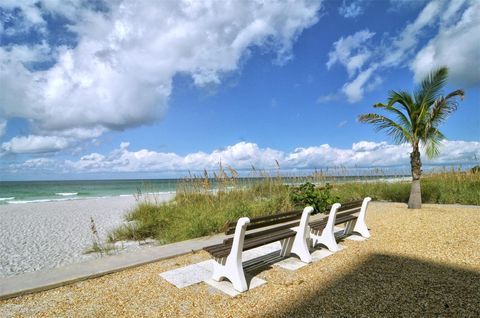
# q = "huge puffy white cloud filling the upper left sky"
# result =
<box><xmin>0</xmin><ymin>0</ymin><xmax>320</xmax><ymax>150</ymax></box>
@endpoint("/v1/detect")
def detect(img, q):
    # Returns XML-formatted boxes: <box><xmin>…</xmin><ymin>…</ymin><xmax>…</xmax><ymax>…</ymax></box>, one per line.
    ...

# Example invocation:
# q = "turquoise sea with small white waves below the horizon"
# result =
<box><xmin>0</xmin><ymin>176</ymin><xmax>404</xmax><ymax>204</ymax></box>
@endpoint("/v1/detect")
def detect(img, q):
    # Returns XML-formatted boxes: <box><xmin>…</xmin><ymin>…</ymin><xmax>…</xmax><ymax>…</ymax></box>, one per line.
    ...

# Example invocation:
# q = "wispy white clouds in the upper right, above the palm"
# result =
<box><xmin>327</xmin><ymin>0</ymin><xmax>480</xmax><ymax>103</ymax></box>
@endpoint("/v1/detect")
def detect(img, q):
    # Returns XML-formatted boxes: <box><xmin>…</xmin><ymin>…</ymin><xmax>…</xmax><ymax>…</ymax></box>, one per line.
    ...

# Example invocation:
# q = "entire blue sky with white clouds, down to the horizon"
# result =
<box><xmin>0</xmin><ymin>0</ymin><xmax>480</xmax><ymax>180</ymax></box>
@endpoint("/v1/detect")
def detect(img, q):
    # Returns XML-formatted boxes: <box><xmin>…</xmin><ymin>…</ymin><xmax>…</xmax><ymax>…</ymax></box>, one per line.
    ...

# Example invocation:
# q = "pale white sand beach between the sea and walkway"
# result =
<box><xmin>0</xmin><ymin>194</ymin><xmax>173</xmax><ymax>277</ymax></box>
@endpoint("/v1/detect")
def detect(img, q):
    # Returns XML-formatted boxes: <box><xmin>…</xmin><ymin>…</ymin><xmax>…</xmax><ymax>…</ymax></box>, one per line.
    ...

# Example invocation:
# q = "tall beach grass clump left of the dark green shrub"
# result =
<box><xmin>108</xmin><ymin>170</ymin><xmax>294</xmax><ymax>244</ymax></box>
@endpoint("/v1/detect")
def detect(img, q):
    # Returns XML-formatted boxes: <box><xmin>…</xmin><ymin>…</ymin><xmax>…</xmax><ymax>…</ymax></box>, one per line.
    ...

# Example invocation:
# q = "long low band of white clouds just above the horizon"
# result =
<box><xmin>8</xmin><ymin>140</ymin><xmax>480</xmax><ymax>175</ymax></box>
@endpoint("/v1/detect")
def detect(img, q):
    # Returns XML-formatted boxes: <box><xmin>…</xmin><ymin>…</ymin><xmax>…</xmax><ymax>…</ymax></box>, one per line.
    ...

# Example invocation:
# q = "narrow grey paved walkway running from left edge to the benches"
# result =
<box><xmin>0</xmin><ymin>234</ymin><xmax>225</xmax><ymax>300</ymax></box>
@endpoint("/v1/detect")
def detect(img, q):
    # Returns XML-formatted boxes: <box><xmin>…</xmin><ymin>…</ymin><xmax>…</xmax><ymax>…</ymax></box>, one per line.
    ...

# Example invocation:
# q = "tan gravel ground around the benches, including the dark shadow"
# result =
<box><xmin>0</xmin><ymin>203</ymin><xmax>480</xmax><ymax>317</ymax></box>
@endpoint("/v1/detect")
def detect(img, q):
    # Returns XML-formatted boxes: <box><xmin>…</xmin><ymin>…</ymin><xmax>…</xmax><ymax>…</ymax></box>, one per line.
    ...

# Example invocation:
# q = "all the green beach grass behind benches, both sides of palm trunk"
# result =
<box><xmin>108</xmin><ymin>167</ymin><xmax>480</xmax><ymax>244</ymax></box>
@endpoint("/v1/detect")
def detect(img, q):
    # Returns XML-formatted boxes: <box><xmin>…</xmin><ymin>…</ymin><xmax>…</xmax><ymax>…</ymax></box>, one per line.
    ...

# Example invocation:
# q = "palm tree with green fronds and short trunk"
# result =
<box><xmin>358</xmin><ymin>67</ymin><xmax>464</xmax><ymax>209</ymax></box>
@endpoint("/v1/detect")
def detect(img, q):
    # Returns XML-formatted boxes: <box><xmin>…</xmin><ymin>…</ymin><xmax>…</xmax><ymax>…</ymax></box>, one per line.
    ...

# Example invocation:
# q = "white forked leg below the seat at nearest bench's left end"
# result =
<box><xmin>212</xmin><ymin>256</ymin><xmax>248</xmax><ymax>292</ymax></box>
